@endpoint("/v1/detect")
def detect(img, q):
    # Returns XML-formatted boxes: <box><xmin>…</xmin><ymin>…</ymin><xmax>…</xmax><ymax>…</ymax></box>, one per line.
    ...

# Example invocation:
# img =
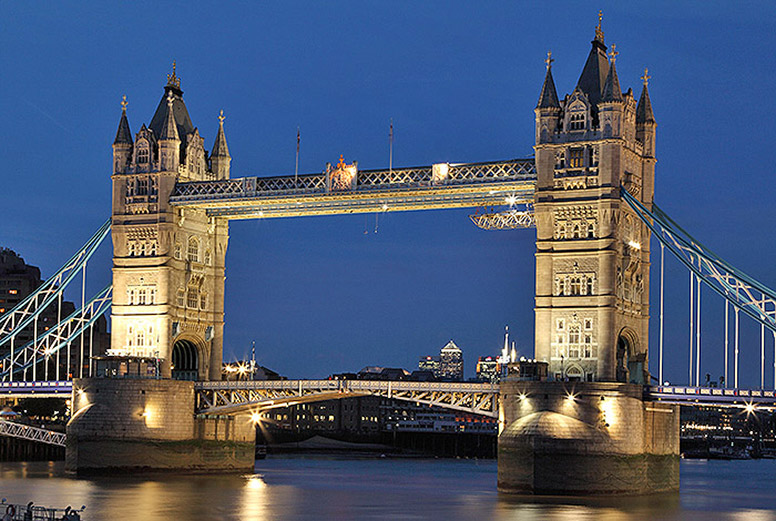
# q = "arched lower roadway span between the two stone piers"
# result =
<box><xmin>195</xmin><ymin>380</ymin><xmax>499</xmax><ymax>418</ymax></box>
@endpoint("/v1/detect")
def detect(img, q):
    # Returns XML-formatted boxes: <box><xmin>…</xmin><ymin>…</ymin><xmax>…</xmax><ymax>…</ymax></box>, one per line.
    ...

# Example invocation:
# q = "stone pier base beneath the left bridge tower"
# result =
<box><xmin>65</xmin><ymin>378</ymin><xmax>256</xmax><ymax>474</ymax></box>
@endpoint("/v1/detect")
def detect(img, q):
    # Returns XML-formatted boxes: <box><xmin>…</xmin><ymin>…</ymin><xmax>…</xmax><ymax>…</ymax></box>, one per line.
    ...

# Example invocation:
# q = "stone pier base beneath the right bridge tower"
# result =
<box><xmin>498</xmin><ymin>380</ymin><xmax>679</xmax><ymax>495</ymax></box>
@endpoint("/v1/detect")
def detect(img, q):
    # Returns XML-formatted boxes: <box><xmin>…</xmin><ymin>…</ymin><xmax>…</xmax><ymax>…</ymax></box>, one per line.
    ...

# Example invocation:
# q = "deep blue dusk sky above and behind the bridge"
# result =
<box><xmin>0</xmin><ymin>1</ymin><xmax>776</xmax><ymax>387</ymax></box>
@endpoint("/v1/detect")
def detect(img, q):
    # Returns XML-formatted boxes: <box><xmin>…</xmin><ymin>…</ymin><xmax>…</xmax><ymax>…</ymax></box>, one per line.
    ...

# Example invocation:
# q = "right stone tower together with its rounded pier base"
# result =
<box><xmin>498</xmin><ymin>20</ymin><xmax>679</xmax><ymax>494</ymax></box>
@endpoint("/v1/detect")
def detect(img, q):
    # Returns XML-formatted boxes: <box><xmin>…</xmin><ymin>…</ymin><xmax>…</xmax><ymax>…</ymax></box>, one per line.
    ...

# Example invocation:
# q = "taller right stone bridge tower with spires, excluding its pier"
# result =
<box><xmin>535</xmin><ymin>23</ymin><xmax>656</xmax><ymax>383</ymax></box>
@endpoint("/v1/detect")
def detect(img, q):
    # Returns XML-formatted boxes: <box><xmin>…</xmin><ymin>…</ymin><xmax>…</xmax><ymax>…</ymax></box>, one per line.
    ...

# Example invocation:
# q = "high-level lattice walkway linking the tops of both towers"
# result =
<box><xmin>170</xmin><ymin>159</ymin><xmax>536</xmax><ymax>219</ymax></box>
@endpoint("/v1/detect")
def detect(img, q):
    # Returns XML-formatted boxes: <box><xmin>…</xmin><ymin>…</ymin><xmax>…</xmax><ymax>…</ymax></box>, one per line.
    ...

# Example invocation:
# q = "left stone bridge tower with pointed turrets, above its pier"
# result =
<box><xmin>110</xmin><ymin>64</ymin><xmax>231</xmax><ymax>380</ymax></box>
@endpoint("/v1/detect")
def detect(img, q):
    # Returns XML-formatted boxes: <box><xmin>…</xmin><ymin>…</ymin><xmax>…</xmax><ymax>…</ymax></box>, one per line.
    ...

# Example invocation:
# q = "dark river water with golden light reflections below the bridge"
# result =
<box><xmin>0</xmin><ymin>456</ymin><xmax>776</xmax><ymax>521</ymax></box>
